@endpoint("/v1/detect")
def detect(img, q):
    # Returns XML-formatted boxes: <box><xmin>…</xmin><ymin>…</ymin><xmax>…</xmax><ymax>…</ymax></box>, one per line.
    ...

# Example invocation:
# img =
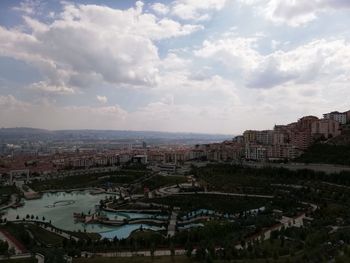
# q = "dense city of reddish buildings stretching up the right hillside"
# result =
<box><xmin>0</xmin><ymin>111</ymin><xmax>350</xmax><ymax>176</ymax></box>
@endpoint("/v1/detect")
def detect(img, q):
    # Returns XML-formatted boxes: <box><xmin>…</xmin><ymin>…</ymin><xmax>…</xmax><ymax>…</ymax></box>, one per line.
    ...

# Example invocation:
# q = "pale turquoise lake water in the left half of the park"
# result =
<box><xmin>4</xmin><ymin>191</ymin><xmax>162</xmax><ymax>238</ymax></box>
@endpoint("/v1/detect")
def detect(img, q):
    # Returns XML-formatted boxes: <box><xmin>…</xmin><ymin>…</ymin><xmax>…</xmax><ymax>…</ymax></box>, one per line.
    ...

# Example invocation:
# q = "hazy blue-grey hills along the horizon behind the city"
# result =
<box><xmin>0</xmin><ymin>127</ymin><xmax>234</xmax><ymax>142</ymax></box>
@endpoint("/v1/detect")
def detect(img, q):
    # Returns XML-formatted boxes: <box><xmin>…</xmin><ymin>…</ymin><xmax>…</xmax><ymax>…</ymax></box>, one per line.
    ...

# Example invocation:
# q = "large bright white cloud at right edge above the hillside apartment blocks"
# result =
<box><xmin>249</xmin><ymin>39</ymin><xmax>350</xmax><ymax>87</ymax></box>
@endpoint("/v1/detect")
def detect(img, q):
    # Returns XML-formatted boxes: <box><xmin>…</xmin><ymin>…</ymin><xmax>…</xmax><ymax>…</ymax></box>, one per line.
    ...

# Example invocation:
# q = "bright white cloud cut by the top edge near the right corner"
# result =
<box><xmin>240</xmin><ymin>0</ymin><xmax>350</xmax><ymax>27</ymax></box>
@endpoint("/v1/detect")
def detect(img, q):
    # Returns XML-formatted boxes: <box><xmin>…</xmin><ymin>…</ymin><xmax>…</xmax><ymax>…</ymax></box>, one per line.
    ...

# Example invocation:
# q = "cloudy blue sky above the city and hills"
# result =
<box><xmin>0</xmin><ymin>0</ymin><xmax>350</xmax><ymax>135</ymax></box>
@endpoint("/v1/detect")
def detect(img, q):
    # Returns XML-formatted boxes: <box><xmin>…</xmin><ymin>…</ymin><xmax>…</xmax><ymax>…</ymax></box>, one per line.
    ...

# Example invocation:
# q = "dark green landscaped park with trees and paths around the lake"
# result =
<box><xmin>2</xmin><ymin>164</ymin><xmax>350</xmax><ymax>263</ymax></box>
